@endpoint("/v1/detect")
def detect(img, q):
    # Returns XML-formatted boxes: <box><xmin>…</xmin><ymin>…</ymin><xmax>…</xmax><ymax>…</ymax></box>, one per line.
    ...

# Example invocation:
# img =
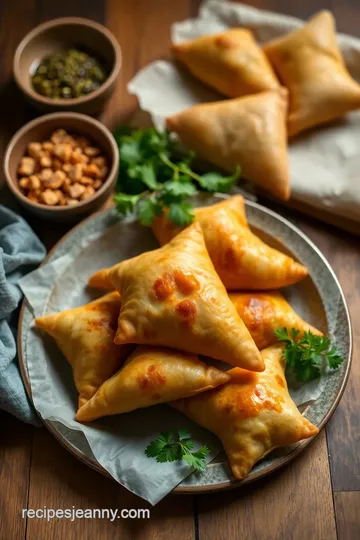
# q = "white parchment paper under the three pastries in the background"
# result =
<box><xmin>128</xmin><ymin>0</ymin><xmax>360</xmax><ymax>221</ymax></box>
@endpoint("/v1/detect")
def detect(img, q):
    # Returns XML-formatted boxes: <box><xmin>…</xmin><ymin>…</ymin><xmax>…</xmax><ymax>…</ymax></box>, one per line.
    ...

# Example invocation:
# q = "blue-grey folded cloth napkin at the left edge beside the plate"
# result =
<box><xmin>0</xmin><ymin>205</ymin><xmax>46</xmax><ymax>425</ymax></box>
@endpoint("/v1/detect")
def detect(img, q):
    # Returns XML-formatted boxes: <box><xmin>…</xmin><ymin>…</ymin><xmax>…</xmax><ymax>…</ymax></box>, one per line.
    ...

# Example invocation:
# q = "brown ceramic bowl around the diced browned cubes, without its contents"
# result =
<box><xmin>4</xmin><ymin>112</ymin><xmax>119</xmax><ymax>221</ymax></box>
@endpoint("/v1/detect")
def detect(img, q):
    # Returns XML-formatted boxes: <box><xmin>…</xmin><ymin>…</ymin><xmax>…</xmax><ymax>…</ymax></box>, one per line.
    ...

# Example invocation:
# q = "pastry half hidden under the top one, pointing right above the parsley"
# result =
<box><xmin>229</xmin><ymin>291</ymin><xmax>322</xmax><ymax>349</ymax></box>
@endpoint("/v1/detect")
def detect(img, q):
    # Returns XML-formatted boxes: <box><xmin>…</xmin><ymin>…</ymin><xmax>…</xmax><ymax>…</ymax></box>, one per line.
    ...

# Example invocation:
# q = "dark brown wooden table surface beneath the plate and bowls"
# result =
<box><xmin>0</xmin><ymin>0</ymin><xmax>360</xmax><ymax>540</ymax></box>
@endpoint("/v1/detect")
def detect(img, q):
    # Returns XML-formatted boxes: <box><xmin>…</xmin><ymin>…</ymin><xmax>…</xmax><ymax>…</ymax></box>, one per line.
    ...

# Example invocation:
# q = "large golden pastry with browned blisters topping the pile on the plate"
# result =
<box><xmin>89</xmin><ymin>223</ymin><xmax>264</xmax><ymax>371</ymax></box>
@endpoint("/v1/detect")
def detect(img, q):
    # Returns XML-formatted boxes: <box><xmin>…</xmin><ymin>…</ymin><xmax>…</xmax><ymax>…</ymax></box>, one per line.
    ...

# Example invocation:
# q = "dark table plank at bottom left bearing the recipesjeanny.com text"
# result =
<box><xmin>26</xmin><ymin>429</ymin><xmax>194</xmax><ymax>540</ymax></box>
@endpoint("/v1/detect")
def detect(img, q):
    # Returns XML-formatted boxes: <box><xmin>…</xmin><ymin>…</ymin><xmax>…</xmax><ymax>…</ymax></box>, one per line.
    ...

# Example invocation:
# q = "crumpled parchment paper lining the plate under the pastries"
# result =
<box><xmin>20</xmin><ymin>205</ymin><xmax>324</xmax><ymax>504</ymax></box>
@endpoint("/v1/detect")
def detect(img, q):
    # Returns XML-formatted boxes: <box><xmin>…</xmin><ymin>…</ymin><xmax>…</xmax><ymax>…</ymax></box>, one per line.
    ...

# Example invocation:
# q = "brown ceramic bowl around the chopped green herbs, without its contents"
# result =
<box><xmin>13</xmin><ymin>17</ymin><xmax>121</xmax><ymax>114</ymax></box>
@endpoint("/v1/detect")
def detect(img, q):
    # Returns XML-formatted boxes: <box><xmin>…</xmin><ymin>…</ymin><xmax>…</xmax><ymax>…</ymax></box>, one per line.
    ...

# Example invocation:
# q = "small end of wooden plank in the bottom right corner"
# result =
<box><xmin>334</xmin><ymin>491</ymin><xmax>360</xmax><ymax>540</ymax></box>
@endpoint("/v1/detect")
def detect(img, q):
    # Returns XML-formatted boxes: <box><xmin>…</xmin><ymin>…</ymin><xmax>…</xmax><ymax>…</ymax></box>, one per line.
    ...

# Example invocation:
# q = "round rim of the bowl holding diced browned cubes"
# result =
<box><xmin>3</xmin><ymin>111</ymin><xmax>119</xmax><ymax>213</ymax></box>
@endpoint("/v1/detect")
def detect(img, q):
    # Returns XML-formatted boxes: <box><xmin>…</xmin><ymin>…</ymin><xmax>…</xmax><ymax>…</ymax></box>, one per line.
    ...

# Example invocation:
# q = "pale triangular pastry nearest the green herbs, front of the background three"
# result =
<box><xmin>166</xmin><ymin>89</ymin><xmax>290</xmax><ymax>200</ymax></box>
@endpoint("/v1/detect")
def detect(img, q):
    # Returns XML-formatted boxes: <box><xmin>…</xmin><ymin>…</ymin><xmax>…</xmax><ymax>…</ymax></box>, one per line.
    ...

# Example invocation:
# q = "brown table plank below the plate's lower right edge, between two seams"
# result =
<box><xmin>198</xmin><ymin>431</ymin><xmax>336</xmax><ymax>540</ymax></box>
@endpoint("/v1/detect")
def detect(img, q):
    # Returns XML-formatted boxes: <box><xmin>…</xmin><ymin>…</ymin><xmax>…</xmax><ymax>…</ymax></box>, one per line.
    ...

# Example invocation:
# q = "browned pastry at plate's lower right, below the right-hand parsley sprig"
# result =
<box><xmin>171</xmin><ymin>344</ymin><xmax>319</xmax><ymax>479</ymax></box>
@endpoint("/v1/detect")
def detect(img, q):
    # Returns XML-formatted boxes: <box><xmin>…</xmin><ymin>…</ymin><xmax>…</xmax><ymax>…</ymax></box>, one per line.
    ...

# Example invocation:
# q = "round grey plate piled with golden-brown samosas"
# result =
<box><xmin>19</xmin><ymin>195</ymin><xmax>351</xmax><ymax>492</ymax></box>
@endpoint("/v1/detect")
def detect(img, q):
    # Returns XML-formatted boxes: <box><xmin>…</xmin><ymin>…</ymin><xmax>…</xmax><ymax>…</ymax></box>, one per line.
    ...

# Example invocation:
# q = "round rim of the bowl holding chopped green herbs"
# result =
<box><xmin>13</xmin><ymin>17</ymin><xmax>122</xmax><ymax>108</ymax></box>
